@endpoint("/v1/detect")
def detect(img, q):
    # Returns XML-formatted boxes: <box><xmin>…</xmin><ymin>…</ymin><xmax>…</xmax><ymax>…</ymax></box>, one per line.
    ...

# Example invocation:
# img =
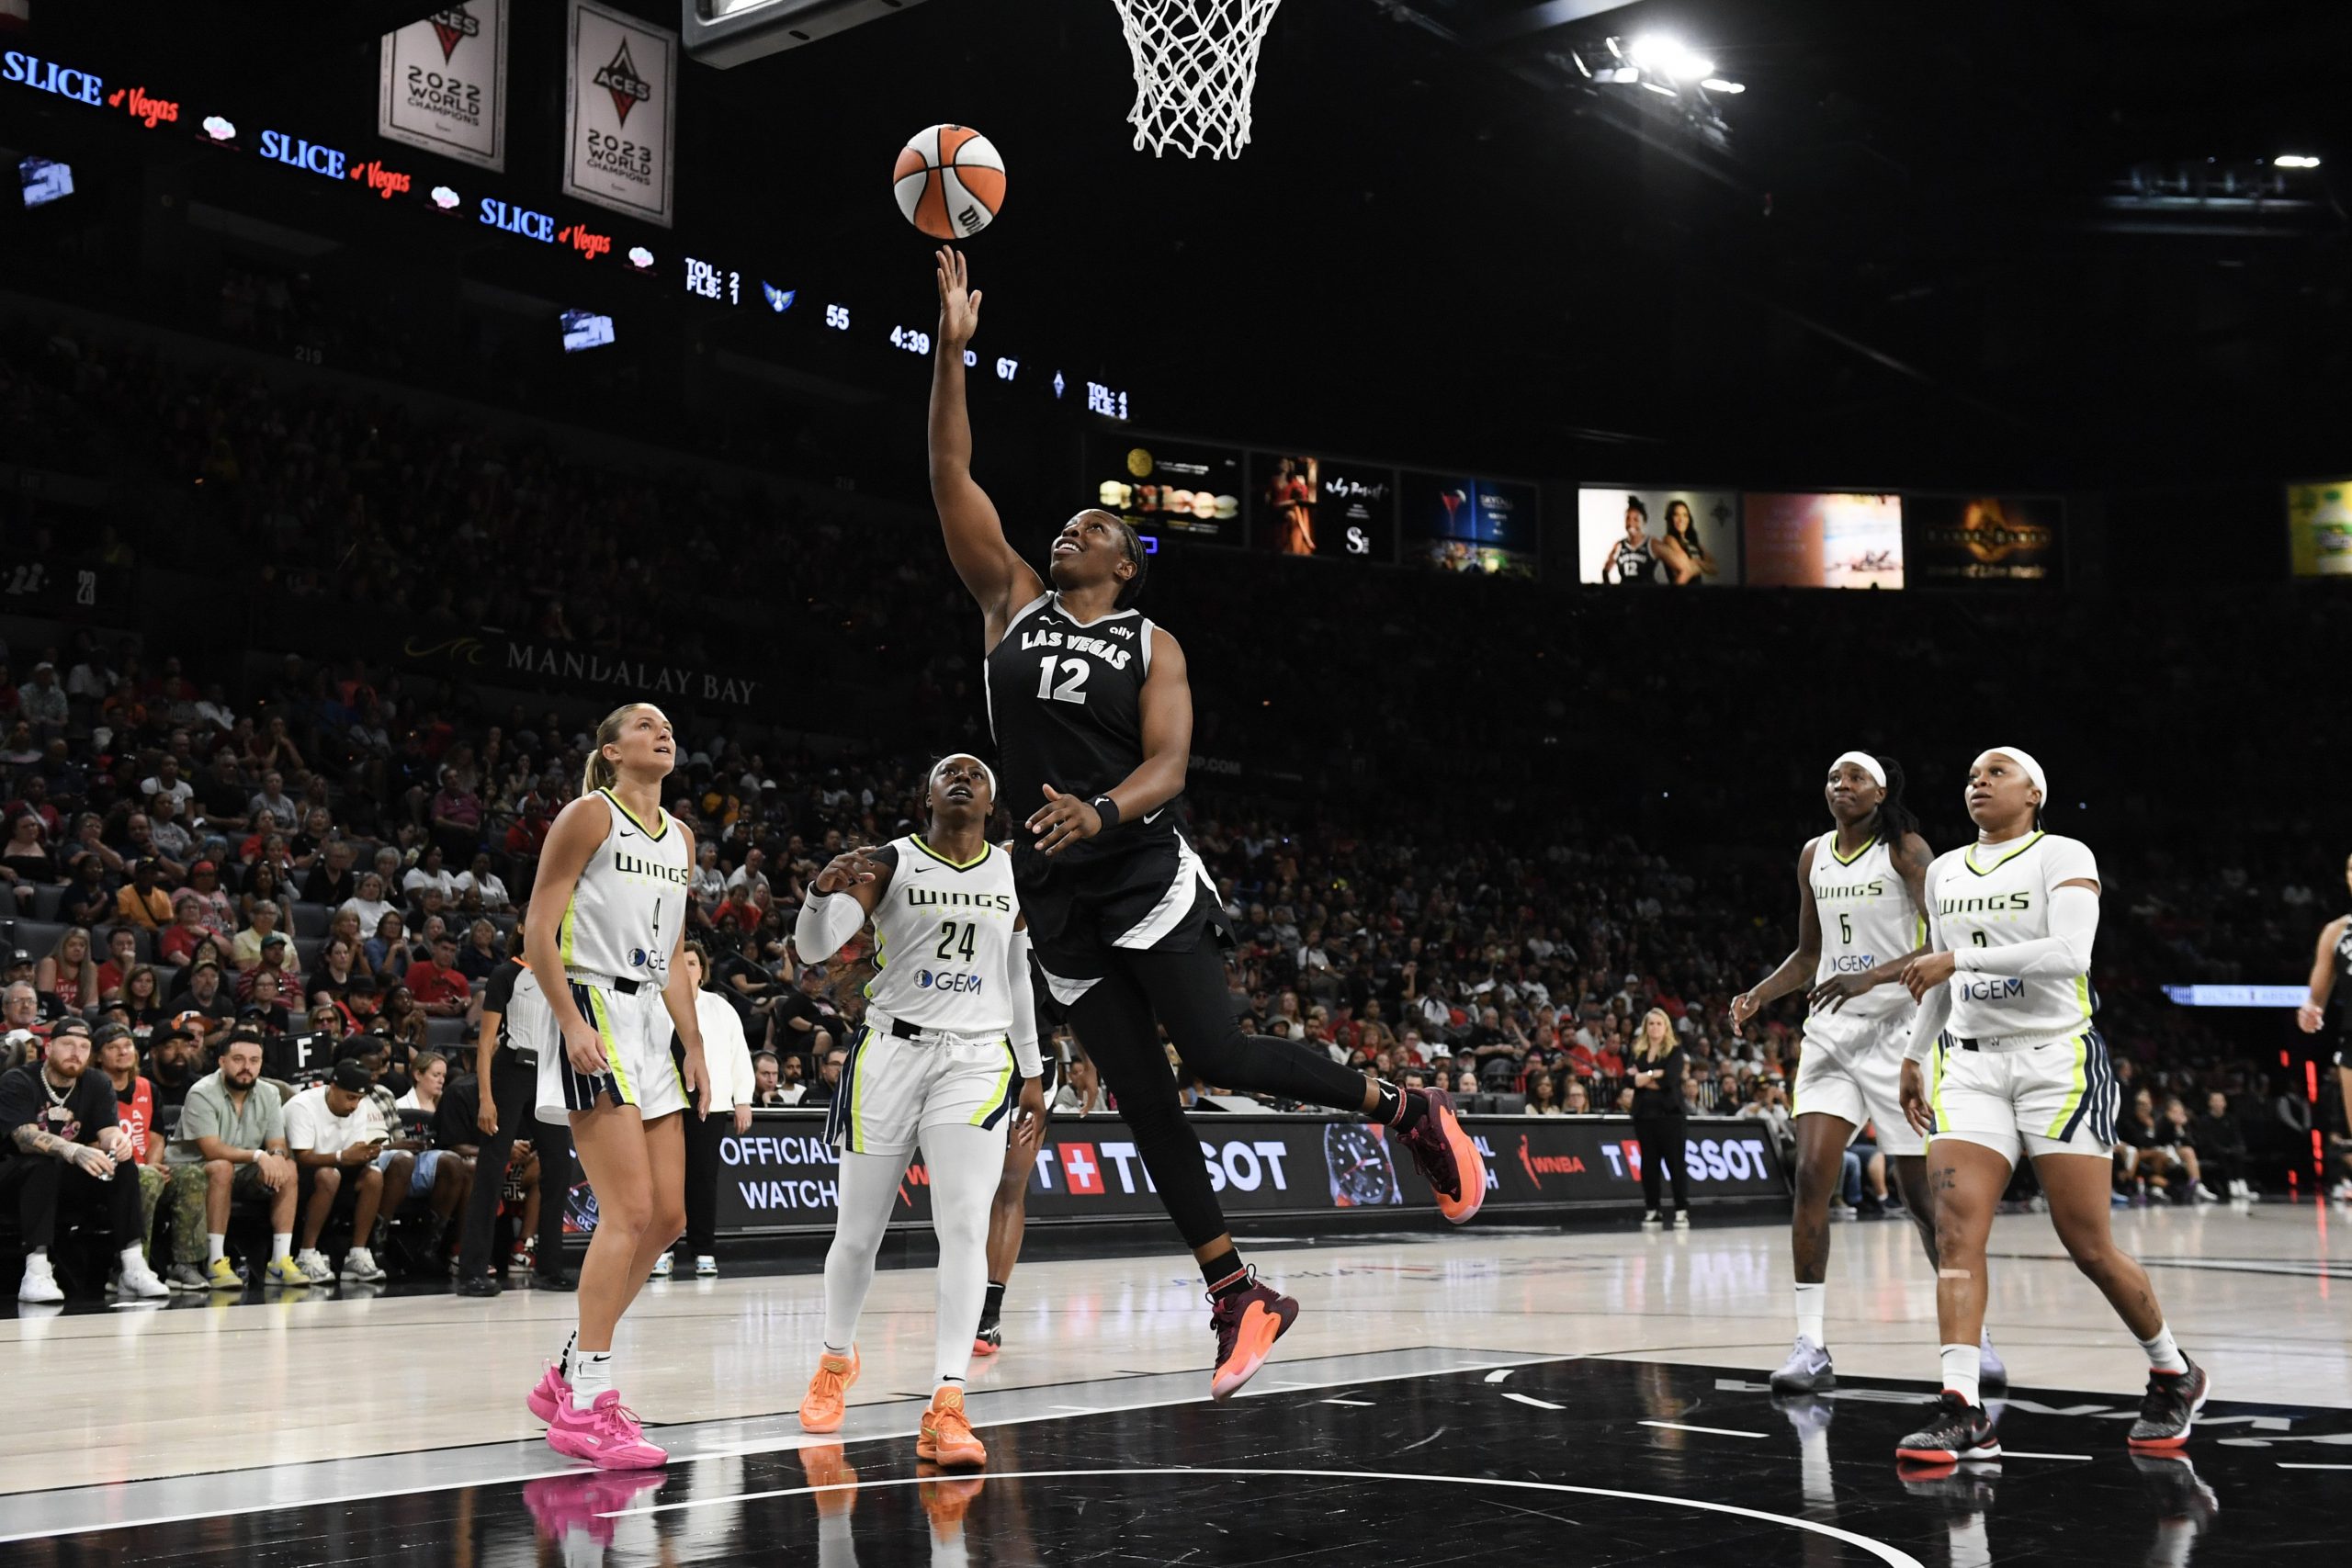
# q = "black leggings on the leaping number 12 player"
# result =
<box><xmin>1070</xmin><ymin>941</ymin><xmax>1364</xmax><ymax>1248</ymax></box>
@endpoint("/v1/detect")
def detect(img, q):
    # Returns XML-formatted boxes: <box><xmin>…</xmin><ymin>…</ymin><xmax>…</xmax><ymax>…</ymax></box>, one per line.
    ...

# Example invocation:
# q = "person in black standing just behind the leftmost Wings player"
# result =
<box><xmin>442</xmin><ymin>924</ymin><xmax>579</xmax><ymax>1295</ymax></box>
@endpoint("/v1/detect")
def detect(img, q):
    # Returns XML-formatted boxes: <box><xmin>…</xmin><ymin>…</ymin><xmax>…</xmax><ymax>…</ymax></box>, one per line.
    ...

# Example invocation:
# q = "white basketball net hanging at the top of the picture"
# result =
<box><xmin>1113</xmin><ymin>0</ymin><xmax>1282</xmax><ymax>157</ymax></box>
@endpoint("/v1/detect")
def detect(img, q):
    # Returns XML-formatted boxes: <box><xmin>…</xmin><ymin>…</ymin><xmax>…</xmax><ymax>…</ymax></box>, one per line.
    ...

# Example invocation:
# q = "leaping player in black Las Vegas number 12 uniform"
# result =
<box><xmin>932</xmin><ymin>249</ymin><xmax>1487</xmax><ymax>1399</ymax></box>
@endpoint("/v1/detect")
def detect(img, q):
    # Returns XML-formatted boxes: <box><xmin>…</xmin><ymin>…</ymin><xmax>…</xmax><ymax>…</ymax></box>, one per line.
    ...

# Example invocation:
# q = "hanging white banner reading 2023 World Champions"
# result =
<box><xmin>564</xmin><ymin>0</ymin><xmax>677</xmax><ymax>228</ymax></box>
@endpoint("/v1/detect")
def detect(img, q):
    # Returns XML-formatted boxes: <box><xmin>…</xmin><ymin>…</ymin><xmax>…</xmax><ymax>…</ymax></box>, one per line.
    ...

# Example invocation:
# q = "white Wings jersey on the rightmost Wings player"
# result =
<box><xmin>1927</xmin><ymin>829</ymin><xmax>2098</xmax><ymax>1039</ymax></box>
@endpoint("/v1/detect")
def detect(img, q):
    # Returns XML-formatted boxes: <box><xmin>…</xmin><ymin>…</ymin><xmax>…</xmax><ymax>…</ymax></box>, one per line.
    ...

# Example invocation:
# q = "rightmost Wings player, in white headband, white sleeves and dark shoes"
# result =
<box><xmin>1895</xmin><ymin>745</ymin><xmax>2211</xmax><ymax>1464</ymax></box>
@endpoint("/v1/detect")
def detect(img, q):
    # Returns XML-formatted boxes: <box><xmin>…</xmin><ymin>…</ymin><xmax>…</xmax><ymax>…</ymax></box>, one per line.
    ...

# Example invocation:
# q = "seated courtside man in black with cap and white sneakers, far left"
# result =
<box><xmin>0</xmin><ymin>1027</ymin><xmax>169</xmax><ymax>1304</ymax></box>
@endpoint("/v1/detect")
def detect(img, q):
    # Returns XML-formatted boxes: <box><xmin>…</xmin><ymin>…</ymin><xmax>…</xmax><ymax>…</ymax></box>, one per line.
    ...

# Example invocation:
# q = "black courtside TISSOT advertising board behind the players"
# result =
<box><xmin>570</xmin><ymin>1110</ymin><xmax>1788</xmax><ymax>1235</ymax></box>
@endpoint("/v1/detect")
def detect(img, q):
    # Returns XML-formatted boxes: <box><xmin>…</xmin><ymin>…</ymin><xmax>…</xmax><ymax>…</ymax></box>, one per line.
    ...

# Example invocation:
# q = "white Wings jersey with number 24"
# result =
<box><xmin>865</xmin><ymin>835</ymin><xmax>1028</xmax><ymax>1039</ymax></box>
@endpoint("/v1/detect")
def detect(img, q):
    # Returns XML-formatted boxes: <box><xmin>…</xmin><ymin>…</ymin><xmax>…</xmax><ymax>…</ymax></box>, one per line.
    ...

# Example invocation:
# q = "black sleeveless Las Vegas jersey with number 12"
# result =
<box><xmin>983</xmin><ymin>592</ymin><xmax>1176</xmax><ymax>865</ymax></box>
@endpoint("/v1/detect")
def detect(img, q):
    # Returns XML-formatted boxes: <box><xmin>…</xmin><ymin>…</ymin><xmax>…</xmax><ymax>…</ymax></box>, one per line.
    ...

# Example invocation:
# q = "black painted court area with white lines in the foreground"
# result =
<box><xmin>41</xmin><ymin>1361</ymin><xmax>2352</xmax><ymax>1568</ymax></box>
